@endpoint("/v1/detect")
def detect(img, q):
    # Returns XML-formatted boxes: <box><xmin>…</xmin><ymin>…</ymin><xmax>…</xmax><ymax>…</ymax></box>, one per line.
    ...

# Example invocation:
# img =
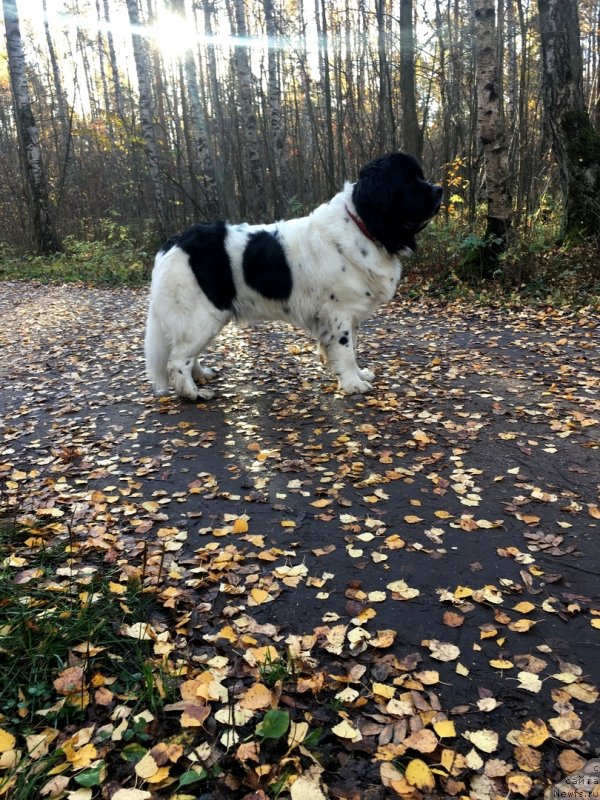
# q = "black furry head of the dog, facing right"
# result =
<box><xmin>352</xmin><ymin>153</ymin><xmax>443</xmax><ymax>253</ymax></box>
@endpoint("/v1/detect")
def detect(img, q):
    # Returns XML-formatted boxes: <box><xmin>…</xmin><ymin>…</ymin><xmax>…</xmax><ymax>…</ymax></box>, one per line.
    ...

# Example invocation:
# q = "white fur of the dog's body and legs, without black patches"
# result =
<box><xmin>145</xmin><ymin>183</ymin><xmax>401</xmax><ymax>400</ymax></box>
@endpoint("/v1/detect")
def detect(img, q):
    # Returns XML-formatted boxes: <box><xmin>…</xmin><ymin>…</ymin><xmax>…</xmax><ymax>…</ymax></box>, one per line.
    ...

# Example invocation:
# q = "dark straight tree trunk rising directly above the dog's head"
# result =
<box><xmin>400</xmin><ymin>0</ymin><xmax>423</xmax><ymax>161</ymax></box>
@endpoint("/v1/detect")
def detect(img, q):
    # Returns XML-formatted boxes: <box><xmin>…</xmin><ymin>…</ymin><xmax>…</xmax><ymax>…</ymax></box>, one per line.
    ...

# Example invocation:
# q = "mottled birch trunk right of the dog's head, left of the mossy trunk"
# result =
<box><xmin>474</xmin><ymin>0</ymin><xmax>512</xmax><ymax>253</ymax></box>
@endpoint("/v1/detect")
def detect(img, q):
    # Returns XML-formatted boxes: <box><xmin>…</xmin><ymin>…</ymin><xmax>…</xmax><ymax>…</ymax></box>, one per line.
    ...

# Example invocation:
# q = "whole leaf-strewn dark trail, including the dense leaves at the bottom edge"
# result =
<box><xmin>0</xmin><ymin>283</ymin><xmax>600</xmax><ymax>800</ymax></box>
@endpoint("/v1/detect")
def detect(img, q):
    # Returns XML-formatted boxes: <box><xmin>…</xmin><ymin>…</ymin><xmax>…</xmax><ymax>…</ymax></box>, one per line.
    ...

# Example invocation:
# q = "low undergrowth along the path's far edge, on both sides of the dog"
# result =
<box><xmin>0</xmin><ymin>211</ymin><xmax>600</xmax><ymax>306</ymax></box>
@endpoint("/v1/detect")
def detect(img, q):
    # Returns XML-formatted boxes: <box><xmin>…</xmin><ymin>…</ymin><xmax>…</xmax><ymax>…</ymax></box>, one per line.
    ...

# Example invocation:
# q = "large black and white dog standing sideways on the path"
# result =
<box><xmin>145</xmin><ymin>153</ymin><xmax>442</xmax><ymax>400</ymax></box>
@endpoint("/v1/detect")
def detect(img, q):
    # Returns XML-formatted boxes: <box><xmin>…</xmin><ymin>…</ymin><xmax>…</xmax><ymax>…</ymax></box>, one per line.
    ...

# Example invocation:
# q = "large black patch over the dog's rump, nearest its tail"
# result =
<box><xmin>169</xmin><ymin>222</ymin><xmax>236</xmax><ymax>311</ymax></box>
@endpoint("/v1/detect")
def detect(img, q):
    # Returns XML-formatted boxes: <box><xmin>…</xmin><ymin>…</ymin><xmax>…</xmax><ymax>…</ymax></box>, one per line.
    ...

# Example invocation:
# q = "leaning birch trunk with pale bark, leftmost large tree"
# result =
<box><xmin>2</xmin><ymin>0</ymin><xmax>61</xmax><ymax>254</ymax></box>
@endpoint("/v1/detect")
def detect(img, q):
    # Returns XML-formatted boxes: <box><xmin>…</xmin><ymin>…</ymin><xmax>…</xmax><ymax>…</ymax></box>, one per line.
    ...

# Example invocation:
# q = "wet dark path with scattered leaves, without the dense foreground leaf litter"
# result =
<box><xmin>0</xmin><ymin>283</ymin><xmax>600</xmax><ymax>797</ymax></box>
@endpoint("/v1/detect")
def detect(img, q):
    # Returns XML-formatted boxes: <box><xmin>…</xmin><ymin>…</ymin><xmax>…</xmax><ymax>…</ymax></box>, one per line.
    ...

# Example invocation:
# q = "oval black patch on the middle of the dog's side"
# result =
<box><xmin>242</xmin><ymin>231</ymin><xmax>292</xmax><ymax>300</ymax></box>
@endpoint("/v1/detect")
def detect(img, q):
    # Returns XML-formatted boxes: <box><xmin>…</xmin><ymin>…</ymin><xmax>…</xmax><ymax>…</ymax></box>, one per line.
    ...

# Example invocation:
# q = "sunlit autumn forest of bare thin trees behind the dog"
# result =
<box><xmin>0</xmin><ymin>0</ymin><xmax>600</xmax><ymax>290</ymax></box>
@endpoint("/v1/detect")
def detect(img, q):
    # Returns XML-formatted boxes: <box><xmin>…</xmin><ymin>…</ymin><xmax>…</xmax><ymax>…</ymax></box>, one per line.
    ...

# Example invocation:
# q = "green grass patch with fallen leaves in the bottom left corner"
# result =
<box><xmin>0</xmin><ymin>516</ymin><xmax>176</xmax><ymax>800</ymax></box>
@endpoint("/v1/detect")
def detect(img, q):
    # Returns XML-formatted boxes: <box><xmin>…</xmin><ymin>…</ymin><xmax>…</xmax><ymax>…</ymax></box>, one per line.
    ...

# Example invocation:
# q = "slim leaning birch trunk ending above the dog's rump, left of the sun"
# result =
<box><xmin>127</xmin><ymin>0</ymin><xmax>170</xmax><ymax>236</ymax></box>
